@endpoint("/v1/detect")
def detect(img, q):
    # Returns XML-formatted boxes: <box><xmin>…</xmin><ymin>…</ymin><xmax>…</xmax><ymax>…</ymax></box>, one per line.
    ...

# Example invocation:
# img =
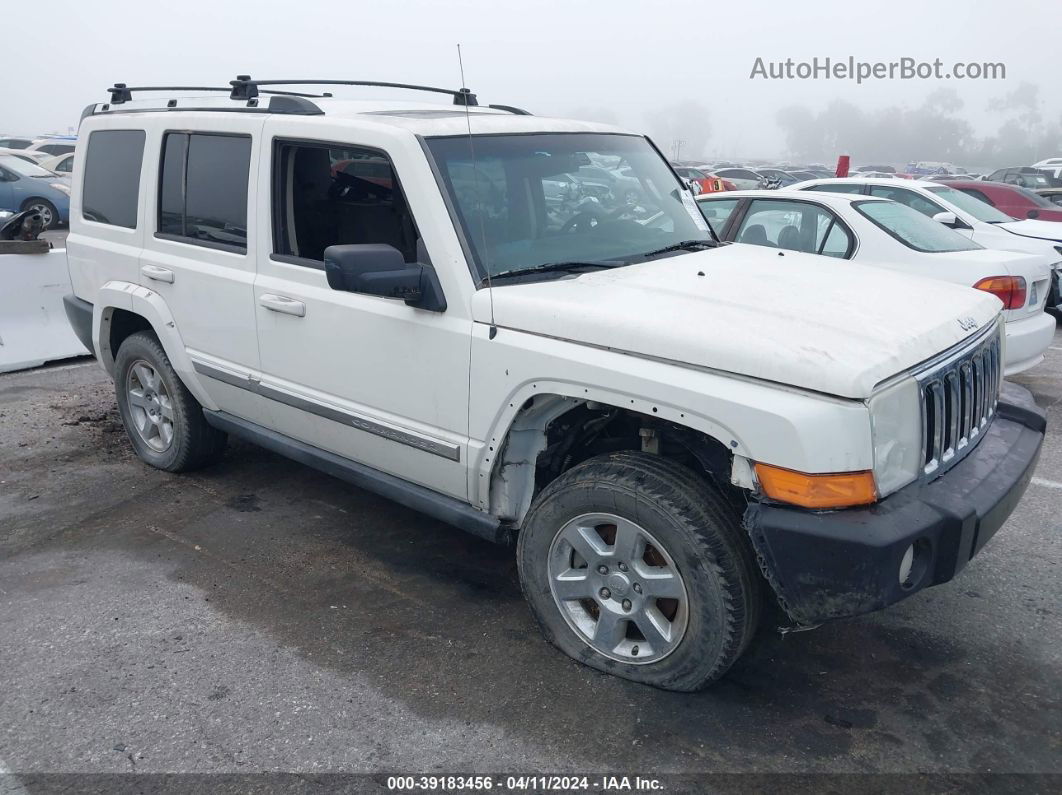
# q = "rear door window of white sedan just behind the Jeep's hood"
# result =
<box><xmin>737</xmin><ymin>198</ymin><xmax>852</xmax><ymax>257</ymax></box>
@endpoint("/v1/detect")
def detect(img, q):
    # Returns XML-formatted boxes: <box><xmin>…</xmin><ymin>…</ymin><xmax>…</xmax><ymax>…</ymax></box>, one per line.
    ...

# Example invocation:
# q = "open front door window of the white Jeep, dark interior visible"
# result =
<box><xmin>273</xmin><ymin>140</ymin><xmax>424</xmax><ymax>267</ymax></box>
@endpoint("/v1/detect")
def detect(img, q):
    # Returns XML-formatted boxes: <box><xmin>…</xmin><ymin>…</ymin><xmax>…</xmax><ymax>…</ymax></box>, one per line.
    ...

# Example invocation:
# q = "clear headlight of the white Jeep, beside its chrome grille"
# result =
<box><xmin>870</xmin><ymin>378</ymin><xmax>922</xmax><ymax>497</ymax></box>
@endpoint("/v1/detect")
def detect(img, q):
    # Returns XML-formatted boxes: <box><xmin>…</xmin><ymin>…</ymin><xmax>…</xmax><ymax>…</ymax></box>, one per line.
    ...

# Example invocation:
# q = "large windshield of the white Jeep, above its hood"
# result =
<box><xmin>427</xmin><ymin>133</ymin><xmax>712</xmax><ymax>277</ymax></box>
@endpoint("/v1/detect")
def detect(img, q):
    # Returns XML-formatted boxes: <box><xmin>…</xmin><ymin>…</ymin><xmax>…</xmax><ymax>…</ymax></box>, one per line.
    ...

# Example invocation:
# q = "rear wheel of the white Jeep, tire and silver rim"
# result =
<box><xmin>115</xmin><ymin>331</ymin><xmax>227</xmax><ymax>472</ymax></box>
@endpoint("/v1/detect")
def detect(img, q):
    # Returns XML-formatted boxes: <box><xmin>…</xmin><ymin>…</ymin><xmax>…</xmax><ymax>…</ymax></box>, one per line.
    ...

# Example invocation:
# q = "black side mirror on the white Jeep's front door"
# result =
<box><xmin>325</xmin><ymin>243</ymin><xmax>446</xmax><ymax>312</ymax></box>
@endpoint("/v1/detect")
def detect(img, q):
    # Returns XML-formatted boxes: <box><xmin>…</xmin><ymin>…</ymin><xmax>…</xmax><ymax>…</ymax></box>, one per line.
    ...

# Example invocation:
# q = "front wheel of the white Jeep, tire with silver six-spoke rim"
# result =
<box><xmin>517</xmin><ymin>452</ymin><xmax>761</xmax><ymax>691</ymax></box>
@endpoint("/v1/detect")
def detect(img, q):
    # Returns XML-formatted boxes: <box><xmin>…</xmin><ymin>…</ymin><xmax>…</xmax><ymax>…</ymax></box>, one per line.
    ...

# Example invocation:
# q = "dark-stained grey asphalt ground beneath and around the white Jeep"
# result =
<box><xmin>0</xmin><ymin>318</ymin><xmax>1062</xmax><ymax>792</ymax></box>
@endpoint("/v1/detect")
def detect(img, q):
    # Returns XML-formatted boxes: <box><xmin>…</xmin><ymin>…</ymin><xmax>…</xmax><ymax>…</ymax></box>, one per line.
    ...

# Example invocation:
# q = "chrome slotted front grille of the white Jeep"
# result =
<box><xmin>914</xmin><ymin>324</ymin><xmax>1003</xmax><ymax>476</ymax></box>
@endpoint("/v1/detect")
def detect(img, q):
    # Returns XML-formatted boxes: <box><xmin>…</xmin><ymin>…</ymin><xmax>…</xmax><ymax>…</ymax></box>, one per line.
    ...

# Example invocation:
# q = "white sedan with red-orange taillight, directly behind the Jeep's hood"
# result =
<box><xmin>697</xmin><ymin>189</ymin><xmax>1055</xmax><ymax>376</ymax></box>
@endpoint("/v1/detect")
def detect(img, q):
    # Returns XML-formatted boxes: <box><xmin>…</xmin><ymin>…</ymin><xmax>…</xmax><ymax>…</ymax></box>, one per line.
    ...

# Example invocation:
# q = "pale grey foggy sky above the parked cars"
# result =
<box><xmin>0</xmin><ymin>0</ymin><xmax>1062</xmax><ymax>160</ymax></box>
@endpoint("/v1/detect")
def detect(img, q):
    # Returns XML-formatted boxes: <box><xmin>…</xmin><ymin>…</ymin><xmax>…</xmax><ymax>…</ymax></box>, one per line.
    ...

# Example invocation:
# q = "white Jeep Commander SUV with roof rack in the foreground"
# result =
<box><xmin>67</xmin><ymin>76</ymin><xmax>1044</xmax><ymax>690</ymax></box>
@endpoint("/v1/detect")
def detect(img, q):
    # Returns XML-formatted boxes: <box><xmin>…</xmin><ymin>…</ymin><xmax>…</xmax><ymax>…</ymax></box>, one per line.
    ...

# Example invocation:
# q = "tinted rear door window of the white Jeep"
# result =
<box><xmin>158</xmin><ymin>133</ymin><xmax>251</xmax><ymax>253</ymax></box>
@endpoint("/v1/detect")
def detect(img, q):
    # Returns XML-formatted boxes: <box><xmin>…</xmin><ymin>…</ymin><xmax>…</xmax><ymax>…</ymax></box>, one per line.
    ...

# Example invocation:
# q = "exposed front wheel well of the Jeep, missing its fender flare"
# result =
<box><xmin>490</xmin><ymin>395</ymin><xmax>747</xmax><ymax>528</ymax></box>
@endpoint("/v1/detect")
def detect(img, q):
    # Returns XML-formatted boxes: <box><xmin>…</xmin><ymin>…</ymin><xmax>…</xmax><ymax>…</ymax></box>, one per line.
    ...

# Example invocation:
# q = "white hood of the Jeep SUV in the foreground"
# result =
<box><xmin>473</xmin><ymin>243</ymin><xmax>1000</xmax><ymax>399</ymax></box>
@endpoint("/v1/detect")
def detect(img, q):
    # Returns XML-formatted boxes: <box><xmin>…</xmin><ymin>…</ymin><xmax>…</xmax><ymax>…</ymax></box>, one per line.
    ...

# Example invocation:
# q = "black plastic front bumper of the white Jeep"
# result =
<box><xmin>744</xmin><ymin>382</ymin><xmax>1046</xmax><ymax>624</ymax></box>
